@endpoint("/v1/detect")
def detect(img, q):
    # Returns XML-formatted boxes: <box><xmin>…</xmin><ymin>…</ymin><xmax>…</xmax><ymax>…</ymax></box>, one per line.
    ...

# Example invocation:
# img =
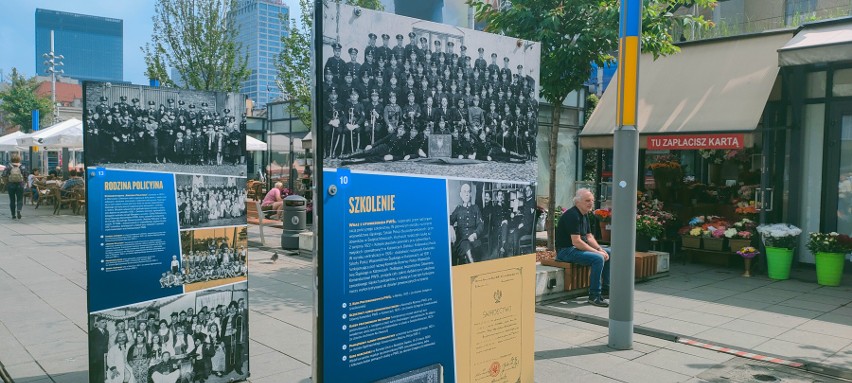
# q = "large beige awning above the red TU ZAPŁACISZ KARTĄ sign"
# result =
<box><xmin>580</xmin><ymin>31</ymin><xmax>792</xmax><ymax>149</ymax></box>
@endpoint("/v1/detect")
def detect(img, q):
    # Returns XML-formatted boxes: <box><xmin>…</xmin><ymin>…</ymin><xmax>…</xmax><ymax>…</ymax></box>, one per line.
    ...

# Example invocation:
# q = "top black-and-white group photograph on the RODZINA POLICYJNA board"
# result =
<box><xmin>83</xmin><ymin>82</ymin><xmax>246</xmax><ymax>176</ymax></box>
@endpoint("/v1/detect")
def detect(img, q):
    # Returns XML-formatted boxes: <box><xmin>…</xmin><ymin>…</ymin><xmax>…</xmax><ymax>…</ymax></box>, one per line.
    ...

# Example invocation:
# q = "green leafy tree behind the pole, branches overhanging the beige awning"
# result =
<box><xmin>468</xmin><ymin>0</ymin><xmax>716</xmax><ymax>249</ymax></box>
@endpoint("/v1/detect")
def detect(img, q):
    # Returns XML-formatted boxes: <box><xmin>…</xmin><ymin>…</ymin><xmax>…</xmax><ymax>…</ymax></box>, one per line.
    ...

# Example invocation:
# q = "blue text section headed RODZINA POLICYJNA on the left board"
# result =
<box><xmin>87</xmin><ymin>168</ymin><xmax>183</xmax><ymax>311</ymax></box>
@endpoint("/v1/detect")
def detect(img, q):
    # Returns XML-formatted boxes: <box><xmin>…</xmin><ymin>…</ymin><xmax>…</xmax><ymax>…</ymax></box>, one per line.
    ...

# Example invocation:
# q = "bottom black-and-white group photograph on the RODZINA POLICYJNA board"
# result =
<box><xmin>89</xmin><ymin>282</ymin><xmax>249</xmax><ymax>383</ymax></box>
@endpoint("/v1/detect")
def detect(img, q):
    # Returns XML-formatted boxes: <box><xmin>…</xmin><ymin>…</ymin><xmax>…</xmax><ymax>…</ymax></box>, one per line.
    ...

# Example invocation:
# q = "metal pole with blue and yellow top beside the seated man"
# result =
<box><xmin>609</xmin><ymin>0</ymin><xmax>642</xmax><ymax>350</ymax></box>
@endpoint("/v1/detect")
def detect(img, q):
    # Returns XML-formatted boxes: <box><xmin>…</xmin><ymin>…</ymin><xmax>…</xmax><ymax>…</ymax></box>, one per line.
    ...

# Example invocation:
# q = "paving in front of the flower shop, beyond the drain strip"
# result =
<box><xmin>540</xmin><ymin>264</ymin><xmax>852</xmax><ymax>379</ymax></box>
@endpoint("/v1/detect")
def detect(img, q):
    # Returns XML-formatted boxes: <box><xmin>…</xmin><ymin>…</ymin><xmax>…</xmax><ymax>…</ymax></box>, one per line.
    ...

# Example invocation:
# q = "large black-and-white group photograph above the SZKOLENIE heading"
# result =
<box><xmin>318</xmin><ymin>4</ymin><xmax>540</xmax><ymax>182</ymax></box>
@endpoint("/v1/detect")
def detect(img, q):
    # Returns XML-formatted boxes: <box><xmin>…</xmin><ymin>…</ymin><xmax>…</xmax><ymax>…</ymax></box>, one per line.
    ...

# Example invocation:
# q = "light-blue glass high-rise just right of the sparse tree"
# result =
<box><xmin>236</xmin><ymin>0</ymin><xmax>290</xmax><ymax>108</ymax></box>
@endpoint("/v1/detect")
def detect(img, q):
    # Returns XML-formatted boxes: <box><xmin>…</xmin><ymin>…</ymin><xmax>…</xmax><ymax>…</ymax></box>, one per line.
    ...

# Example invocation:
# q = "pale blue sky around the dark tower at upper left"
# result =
<box><xmin>0</xmin><ymin>0</ymin><xmax>300</xmax><ymax>84</ymax></box>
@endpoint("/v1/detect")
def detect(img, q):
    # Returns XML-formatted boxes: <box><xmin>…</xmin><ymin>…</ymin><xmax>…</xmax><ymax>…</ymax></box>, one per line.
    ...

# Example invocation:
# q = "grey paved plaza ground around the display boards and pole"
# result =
<box><xmin>0</xmin><ymin>202</ymin><xmax>852</xmax><ymax>383</ymax></box>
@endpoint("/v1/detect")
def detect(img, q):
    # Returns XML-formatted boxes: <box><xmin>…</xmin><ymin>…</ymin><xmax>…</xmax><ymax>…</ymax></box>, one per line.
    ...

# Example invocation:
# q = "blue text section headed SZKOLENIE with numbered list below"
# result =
<box><xmin>323</xmin><ymin>169</ymin><xmax>455</xmax><ymax>382</ymax></box>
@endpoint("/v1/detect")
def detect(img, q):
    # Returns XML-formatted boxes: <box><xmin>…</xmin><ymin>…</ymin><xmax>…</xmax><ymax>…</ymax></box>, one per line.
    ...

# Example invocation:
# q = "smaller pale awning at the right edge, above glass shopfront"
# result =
<box><xmin>778</xmin><ymin>18</ymin><xmax>852</xmax><ymax>66</ymax></box>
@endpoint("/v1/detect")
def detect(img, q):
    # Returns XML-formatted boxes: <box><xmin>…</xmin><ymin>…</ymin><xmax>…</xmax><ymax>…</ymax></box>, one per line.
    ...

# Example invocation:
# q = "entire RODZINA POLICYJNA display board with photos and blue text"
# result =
<box><xmin>83</xmin><ymin>82</ymin><xmax>253</xmax><ymax>383</ymax></box>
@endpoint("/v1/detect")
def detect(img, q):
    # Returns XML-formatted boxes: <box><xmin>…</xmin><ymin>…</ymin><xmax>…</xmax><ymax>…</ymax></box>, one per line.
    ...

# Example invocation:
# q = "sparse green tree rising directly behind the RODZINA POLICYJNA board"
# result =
<box><xmin>142</xmin><ymin>0</ymin><xmax>251</xmax><ymax>92</ymax></box>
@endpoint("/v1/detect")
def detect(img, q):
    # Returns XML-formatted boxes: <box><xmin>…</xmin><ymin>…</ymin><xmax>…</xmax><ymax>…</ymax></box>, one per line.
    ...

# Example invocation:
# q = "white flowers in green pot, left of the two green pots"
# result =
<box><xmin>757</xmin><ymin>223</ymin><xmax>802</xmax><ymax>279</ymax></box>
